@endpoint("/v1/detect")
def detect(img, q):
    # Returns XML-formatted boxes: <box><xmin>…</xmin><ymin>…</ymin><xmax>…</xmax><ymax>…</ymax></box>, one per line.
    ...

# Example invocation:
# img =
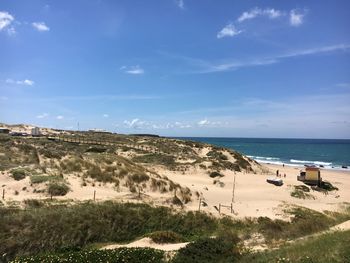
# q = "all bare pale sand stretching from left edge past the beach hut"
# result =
<box><xmin>0</xmin><ymin>160</ymin><xmax>350</xmax><ymax>222</ymax></box>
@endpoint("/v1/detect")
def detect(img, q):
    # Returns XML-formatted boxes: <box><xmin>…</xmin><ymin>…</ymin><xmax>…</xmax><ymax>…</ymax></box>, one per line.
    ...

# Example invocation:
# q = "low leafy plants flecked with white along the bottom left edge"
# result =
<box><xmin>12</xmin><ymin>248</ymin><xmax>165</xmax><ymax>263</ymax></box>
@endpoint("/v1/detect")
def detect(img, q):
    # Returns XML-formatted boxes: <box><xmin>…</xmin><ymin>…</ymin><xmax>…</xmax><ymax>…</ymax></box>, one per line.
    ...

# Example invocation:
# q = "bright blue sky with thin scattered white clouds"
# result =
<box><xmin>0</xmin><ymin>0</ymin><xmax>350</xmax><ymax>138</ymax></box>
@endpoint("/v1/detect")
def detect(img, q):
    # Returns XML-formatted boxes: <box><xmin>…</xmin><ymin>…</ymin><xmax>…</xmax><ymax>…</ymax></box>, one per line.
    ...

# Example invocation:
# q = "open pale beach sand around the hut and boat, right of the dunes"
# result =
<box><xmin>163</xmin><ymin>164</ymin><xmax>350</xmax><ymax>219</ymax></box>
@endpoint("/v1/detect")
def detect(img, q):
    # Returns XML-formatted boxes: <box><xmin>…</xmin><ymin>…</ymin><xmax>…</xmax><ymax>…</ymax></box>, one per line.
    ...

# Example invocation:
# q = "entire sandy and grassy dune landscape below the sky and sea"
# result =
<box><xmin>0</xmin><ymin>128</ymin><xmax>350</xmax><ymax>263</ymax></box>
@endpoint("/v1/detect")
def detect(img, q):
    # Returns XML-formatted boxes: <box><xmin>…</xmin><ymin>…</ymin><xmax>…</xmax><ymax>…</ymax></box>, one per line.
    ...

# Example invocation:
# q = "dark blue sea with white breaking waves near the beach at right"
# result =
<box><xmin>178</xmin><ymin>137</ymin><xmax>350</xmax><ymax>169</ymax></box>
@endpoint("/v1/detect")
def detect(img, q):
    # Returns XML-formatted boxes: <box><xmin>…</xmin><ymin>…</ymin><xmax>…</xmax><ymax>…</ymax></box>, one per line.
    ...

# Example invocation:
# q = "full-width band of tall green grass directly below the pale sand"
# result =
<box><xmin>0</xmin><ymin>200</ymin><xmax>350</xmax><ymax>262</ymax></box>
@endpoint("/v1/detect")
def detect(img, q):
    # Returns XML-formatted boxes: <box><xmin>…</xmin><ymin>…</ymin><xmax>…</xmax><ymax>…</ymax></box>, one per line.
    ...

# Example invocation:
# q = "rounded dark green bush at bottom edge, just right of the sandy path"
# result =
<box><xmin>173</xmin><ymin>237</ymin><xmax>241</xmax><ymax>263</ymax></box>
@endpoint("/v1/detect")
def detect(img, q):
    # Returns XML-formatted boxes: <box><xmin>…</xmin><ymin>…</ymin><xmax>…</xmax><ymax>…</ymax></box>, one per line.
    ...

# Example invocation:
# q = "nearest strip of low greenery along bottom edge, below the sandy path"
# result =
<box><xmin>12</xmin><ymin>231</ymin><xmax>350</xmax><ymax>263</ymax></box>
